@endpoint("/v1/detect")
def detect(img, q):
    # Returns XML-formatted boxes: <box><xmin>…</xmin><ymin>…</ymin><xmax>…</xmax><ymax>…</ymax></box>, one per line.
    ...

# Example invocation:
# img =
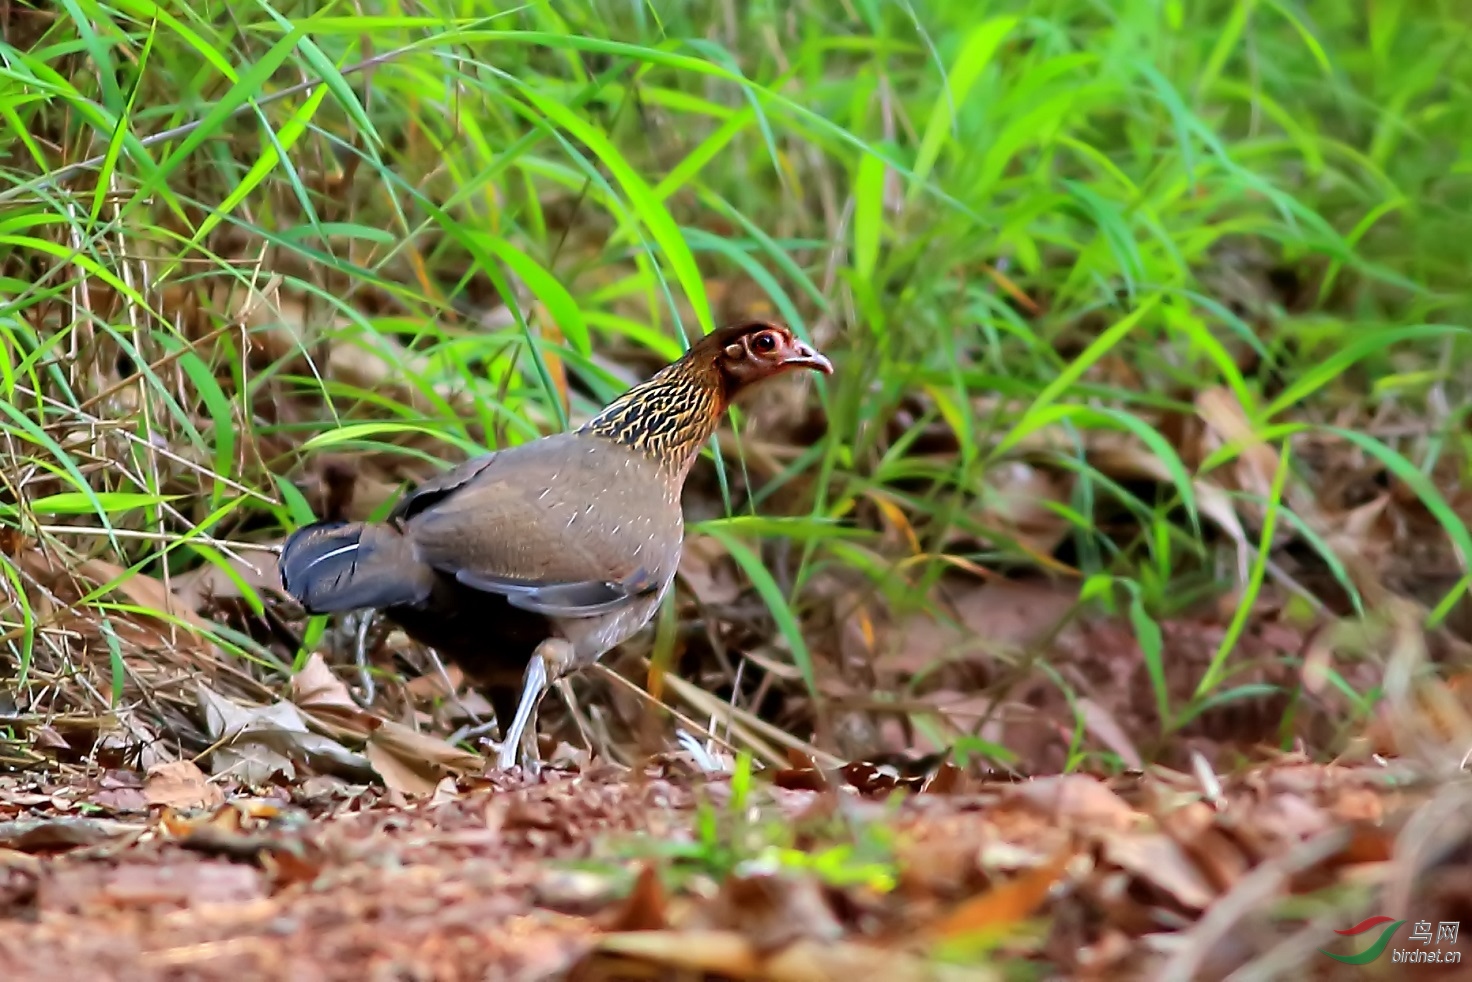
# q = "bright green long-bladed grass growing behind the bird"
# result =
<box><xmin>0</xmin><ymin>0</ymin><xmax>1472</xmax><ymax>765</ymax></box>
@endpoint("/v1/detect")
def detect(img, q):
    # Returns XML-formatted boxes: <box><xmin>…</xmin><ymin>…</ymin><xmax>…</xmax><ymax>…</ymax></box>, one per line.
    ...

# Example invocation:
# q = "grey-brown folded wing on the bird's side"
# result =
<box><xmin>405</xmin><ymin>434</ymin><xmax>683</xmax><ymax>617</ymax></box>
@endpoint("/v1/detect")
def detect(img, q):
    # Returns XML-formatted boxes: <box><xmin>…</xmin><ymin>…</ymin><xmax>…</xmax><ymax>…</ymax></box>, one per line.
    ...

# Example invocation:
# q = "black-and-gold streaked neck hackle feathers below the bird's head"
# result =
<box><xmin>581</xmin><ymin>355</ymin><xmax>730</xmax><ymax>477</ymax></box>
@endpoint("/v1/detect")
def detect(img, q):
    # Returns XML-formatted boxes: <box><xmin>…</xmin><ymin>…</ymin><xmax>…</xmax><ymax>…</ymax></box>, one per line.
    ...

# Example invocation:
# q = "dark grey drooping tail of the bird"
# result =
<box><xmin>278</xmin><ymin>521</ymin><xmax>433</xmax><ymax>614</ymax></box>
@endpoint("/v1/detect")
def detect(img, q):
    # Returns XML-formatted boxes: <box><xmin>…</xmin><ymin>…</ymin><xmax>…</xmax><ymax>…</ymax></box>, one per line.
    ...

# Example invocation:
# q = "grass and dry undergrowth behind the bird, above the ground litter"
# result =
<box><xmin>0</xmin><ymin>0</ymin><xmax>1472</xmax><ymax>771</ymax></box>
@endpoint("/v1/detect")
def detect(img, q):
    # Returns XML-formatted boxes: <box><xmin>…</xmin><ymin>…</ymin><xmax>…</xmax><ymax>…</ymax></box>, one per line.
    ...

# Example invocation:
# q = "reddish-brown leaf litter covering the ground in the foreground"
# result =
<box><xmin>0</xmin><ymin>744</ymin><xmax>1472</xmax><ymax>979</ymax></box>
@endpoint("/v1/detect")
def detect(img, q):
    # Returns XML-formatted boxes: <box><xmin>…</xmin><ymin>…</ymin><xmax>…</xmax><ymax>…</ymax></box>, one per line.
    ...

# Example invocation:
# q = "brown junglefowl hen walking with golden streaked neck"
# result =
<box><xmin>280</xmin><ymin>319</ymin><xmax>833</xmax><ymax>769</ymax></box>
